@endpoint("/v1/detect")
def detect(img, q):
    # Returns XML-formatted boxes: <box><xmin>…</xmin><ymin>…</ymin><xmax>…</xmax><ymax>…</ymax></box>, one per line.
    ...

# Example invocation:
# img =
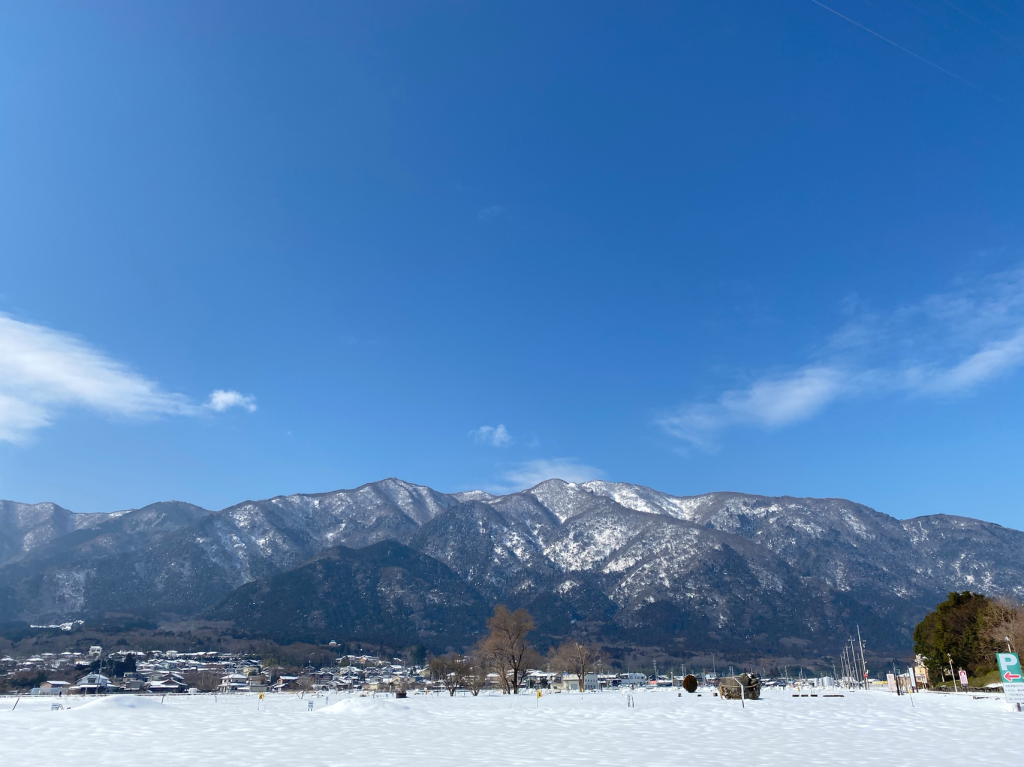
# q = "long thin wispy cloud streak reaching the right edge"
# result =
<box><xmin>657</xmin><ymin>269</ymin><xmax>1024</xmax><ymax>449</ymax></box>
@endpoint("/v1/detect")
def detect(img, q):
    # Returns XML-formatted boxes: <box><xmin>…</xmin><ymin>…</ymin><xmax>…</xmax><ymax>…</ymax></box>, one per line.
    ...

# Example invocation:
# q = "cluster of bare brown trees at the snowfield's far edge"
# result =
<box><xmin>429</xmin><ymin>604</ymin><xmax>599</xmax><ymax>695</ymax></box>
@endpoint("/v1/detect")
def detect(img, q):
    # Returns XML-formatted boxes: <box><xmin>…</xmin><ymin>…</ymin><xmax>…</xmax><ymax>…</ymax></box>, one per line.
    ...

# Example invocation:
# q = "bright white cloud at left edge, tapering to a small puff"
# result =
<box><xmin>0</xmin><ymin>314</ymin><xmax>255</xmax><ymax>442</ymax></box>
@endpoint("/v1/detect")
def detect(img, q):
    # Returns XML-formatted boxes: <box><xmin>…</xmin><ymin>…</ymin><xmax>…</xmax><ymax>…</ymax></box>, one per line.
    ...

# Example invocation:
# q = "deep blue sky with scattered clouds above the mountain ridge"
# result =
<box><xmin>0</xmin><ymin>0</ymin><xmax>1024</xmax><ymax>527</ymax></box>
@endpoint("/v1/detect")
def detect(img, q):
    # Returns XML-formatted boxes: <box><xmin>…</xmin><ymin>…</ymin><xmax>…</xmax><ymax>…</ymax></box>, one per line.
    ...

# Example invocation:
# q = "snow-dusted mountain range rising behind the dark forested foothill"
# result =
<box><xmin>0</xmin><ymin>479</ymin><xmax>1024</xmax><ymax>653</ymax></box>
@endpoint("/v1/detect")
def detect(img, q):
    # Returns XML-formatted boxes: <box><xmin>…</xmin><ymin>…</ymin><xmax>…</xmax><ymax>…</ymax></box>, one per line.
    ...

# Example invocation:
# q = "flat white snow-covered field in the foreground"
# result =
<box><xmin>0</xmin><ymin>690</ymin><xmax>1024</xmax><ymax>767</ymax></box>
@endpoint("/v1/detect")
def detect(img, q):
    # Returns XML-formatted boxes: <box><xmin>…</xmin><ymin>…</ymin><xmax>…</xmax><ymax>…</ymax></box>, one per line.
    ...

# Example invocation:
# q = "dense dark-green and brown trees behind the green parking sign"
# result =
<box><xmin>913</xmin><ymin>591</ymin><xmax>1024</xmax><ymax>679</ymax></box>
